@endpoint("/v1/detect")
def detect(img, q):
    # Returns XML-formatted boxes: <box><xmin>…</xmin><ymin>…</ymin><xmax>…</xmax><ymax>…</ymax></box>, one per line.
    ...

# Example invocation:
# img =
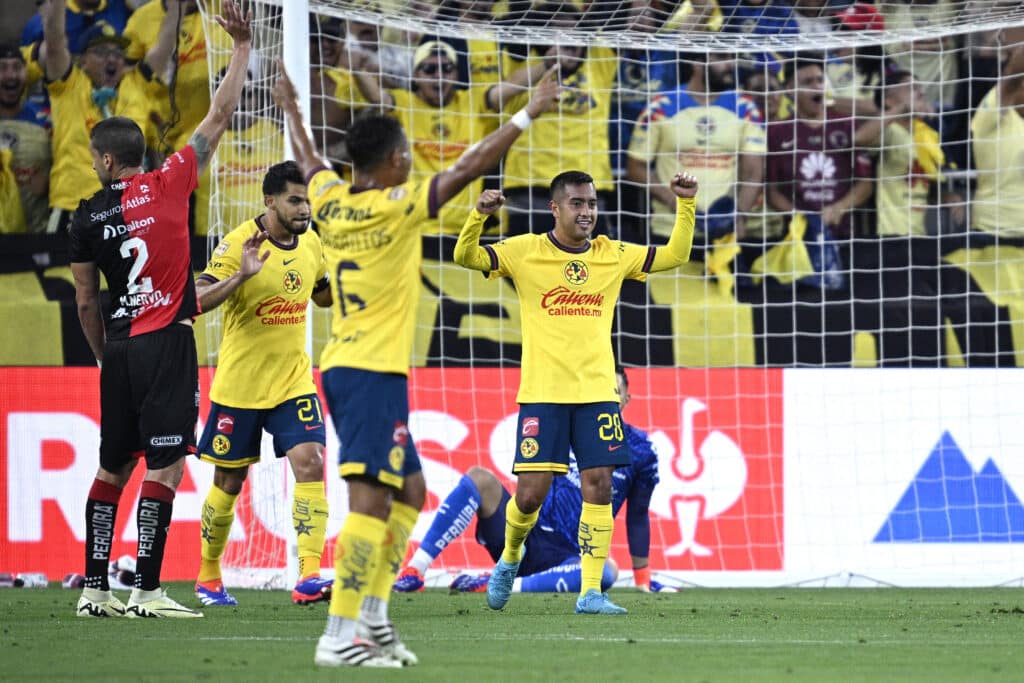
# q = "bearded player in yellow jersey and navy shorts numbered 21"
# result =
<box><xmin>196</xmin><ymin>162</ymin><xmax>331</xmax><ymax>605</ymax></box>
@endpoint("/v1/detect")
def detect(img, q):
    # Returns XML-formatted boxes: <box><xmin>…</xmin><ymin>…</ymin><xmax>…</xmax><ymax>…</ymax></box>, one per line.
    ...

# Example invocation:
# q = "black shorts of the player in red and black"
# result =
<box><xmin>99</xmin><ymin>324</ymin><xmax>199</xmax><ymax>472</ymax></box>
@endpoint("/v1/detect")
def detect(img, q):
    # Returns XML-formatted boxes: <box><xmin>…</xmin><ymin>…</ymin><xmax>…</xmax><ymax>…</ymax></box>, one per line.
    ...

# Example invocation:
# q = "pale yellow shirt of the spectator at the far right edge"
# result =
<box><xmin>971</xmin><ymin>85</ymin><xmax>1024</xmax><ymax>237</ymax></box>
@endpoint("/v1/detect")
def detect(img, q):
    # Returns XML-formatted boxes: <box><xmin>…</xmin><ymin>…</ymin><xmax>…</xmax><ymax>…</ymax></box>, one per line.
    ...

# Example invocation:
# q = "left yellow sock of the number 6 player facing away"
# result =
<box><xmin>328</xmin><ymin>512</ymin><xmax>387</xmax><ymax>621</ymax></box>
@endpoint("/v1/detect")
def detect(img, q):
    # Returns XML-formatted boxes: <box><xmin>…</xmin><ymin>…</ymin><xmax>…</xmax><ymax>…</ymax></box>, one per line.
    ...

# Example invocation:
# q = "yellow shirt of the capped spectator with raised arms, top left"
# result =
<box><xmin>46</xmin><ymin>66</ymin><xmax>150</xmax><ymax>211</ymax></box>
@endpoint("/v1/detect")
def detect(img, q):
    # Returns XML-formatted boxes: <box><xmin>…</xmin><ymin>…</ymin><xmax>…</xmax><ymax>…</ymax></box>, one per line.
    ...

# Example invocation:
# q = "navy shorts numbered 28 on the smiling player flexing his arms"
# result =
<box><xmin>512</xmin><ymin>400</ymin><xmax>630</xmax><ymax>474</ymax></box>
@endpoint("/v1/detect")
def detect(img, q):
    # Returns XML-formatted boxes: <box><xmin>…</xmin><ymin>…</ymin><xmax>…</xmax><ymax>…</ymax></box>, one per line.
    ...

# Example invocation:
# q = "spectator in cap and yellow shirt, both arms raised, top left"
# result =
<box><xmin>40</xmin><ymin>0</ymin><xmax>179</xmax><ymax>232</ymax></box>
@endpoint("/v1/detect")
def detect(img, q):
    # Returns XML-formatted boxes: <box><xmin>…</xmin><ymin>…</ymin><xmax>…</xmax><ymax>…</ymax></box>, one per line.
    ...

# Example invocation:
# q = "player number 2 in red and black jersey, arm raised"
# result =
<box><xmin>69</xmin><ymin>0</ymin><xmax>252</xmax><ymax>617</ymax></box>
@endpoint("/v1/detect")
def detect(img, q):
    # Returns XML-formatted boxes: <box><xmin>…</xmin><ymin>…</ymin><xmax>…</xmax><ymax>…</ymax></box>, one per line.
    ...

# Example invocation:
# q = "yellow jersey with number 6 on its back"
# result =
<box><xmin>309</xmin><ymin>169</ymin><xmax>437</xmax><ymax>375</ymax></box>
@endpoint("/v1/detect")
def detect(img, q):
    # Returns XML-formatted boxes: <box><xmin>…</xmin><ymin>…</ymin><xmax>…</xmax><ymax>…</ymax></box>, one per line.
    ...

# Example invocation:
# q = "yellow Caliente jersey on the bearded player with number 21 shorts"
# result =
<box><xmin>200</xmin><ymin>218</ymin><xmax>327</xmax><ymax>410</ymax></box>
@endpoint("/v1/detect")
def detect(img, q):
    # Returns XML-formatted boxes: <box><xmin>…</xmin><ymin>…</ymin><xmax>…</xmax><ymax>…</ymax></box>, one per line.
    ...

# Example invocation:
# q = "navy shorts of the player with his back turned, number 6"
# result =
<box><xmin>323</xmin><ymin>368</ymin><xmax>423</xmax><ymax>489</ymax></box>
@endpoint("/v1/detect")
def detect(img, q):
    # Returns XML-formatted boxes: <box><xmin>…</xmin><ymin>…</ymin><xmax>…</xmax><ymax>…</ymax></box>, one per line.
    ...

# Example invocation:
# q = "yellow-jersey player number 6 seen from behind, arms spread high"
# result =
<box><xmin>273</xmin><ymin>57</ymin><xmax>558</xmax><ymax>667</ymax></box>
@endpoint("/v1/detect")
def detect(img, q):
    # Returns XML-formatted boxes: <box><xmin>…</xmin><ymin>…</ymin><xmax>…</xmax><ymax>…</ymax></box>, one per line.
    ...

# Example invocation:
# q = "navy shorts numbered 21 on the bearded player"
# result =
<box><xmin>199</xmin><ymin>393</ymin><xmax>327</xmax><ymax>467</ymax></box>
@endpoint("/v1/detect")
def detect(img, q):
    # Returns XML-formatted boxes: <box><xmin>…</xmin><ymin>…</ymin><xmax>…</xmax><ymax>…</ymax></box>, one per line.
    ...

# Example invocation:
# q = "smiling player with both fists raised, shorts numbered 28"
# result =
<box><xmin>455</xmin><ymin>171</ymin><xmax>697</xmax><ymax>614</ymax></box>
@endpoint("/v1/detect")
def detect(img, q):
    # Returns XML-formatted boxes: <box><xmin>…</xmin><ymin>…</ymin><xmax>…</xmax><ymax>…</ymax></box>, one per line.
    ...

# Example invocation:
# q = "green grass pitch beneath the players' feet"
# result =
<box><xmin>0</xmin><ymin>585</ymin><xmax>1024</xmax><ymax>683</ymax></box>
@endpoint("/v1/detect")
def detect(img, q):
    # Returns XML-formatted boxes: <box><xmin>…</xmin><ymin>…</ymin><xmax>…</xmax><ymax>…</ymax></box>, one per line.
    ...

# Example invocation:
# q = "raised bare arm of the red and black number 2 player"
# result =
<box><xmin>188</xmin><ymin>0</ymin><xmax>253</xmax><ymax>170</ymax></box>
